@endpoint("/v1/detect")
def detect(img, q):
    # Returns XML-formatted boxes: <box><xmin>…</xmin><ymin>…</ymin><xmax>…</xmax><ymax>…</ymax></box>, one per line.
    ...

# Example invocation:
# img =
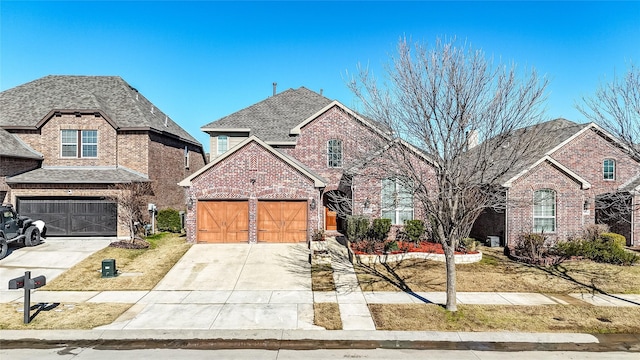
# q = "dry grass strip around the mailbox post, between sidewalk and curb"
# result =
<box><xmin>0</xmin><ymin>303</ymin><xmax>131</xmax><ymax>330</ymax></box>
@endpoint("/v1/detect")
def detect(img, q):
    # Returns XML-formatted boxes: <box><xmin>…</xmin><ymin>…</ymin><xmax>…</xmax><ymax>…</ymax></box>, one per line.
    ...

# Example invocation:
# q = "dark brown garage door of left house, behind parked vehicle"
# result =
<box><xmin>17</xmin><ymin>198</ymin><xmax>118</xmax><ymax>236</ymax></box>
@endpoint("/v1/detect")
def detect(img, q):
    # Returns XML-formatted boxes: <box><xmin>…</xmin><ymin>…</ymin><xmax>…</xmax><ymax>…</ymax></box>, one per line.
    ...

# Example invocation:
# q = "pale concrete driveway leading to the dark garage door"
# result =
<box><xmin>0</xmin><ymin>237</ymin><xmax>115</xmax><ymax>302</ymax></box>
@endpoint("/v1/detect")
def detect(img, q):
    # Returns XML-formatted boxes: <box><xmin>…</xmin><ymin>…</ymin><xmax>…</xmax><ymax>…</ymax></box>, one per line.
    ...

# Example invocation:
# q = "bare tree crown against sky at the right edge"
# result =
<box><xmin>576</xmin><ymin>65</ymin><xmax>640</xmax><ymax>159</ymax></box>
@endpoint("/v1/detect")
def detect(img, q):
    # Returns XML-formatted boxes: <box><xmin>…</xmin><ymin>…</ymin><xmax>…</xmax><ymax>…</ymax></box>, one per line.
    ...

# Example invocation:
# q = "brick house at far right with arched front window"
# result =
<box><xmin>471</xmin><ymin>119</ymin><xmax>640</xmax><ymax>246</ymax></box>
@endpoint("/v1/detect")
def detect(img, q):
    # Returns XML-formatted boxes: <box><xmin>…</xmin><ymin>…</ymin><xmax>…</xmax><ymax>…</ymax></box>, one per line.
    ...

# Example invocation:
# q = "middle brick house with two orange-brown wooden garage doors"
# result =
<box><xmin>180</xmin><ymin>87</ymin><xmax>432</xmax><ymax>242</ymax></box>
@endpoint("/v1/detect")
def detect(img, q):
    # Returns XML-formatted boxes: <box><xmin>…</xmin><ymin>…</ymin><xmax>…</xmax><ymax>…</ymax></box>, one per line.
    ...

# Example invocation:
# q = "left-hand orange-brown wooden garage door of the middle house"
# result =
<box><xmin>196</xmin><ymin>201</ymin><xmax>249</xmax><ymax>243</ymax></box>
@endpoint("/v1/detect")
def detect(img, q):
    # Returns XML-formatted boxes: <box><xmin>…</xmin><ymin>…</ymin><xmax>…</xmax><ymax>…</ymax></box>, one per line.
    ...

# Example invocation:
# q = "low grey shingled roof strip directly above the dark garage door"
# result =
<box><xmin>6</xmin><ymin>166</ymin><xmax>149</xmax><ymax>184</ymax></box>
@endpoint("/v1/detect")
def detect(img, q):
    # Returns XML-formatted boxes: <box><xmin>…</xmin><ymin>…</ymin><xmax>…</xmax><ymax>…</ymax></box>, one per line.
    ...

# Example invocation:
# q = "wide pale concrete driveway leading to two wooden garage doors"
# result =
<box><xmin>100</xmin><ymin>243</ymin><xmax>318</xmax><ymax>330</ymax></box>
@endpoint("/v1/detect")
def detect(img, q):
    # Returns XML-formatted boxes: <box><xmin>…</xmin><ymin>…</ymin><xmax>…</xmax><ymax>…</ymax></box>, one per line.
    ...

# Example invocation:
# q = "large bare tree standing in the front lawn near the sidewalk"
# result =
<box><xmin>349</xmin><ymin>39</ymin><xmax>547</xmax><ymax>311</ymax></box>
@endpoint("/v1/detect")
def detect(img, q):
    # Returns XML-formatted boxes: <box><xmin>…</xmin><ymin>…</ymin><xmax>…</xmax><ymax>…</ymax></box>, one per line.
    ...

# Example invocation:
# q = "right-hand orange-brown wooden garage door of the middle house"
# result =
<box><xmin>258</xmin><ymin>201</ymin><xmax>307</xmax><ymax>242</ymax></box>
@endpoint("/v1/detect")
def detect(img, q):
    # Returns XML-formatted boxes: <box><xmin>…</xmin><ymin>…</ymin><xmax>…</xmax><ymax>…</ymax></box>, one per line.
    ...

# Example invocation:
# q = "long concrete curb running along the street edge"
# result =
<box><xmin>0</xmin><ymin>330</ymin><xmax>640</xmax><ymax>353</ymax></box>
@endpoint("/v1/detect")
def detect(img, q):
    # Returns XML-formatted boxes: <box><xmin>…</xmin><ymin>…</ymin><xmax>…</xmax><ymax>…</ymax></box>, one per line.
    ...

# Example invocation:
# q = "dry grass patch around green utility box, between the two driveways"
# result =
<box><xmin>43</xmin><ymin>233</ymin><xmax>191</xmax><ymax>291</ymax></box>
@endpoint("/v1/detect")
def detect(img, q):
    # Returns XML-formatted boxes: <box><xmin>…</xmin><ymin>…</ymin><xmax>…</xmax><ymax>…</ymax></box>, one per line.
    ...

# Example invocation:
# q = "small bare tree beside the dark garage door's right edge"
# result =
<box><xmin>111</xmin><ymin>181</ymin><xmax>153</xmax><ymax>241</ymax></box>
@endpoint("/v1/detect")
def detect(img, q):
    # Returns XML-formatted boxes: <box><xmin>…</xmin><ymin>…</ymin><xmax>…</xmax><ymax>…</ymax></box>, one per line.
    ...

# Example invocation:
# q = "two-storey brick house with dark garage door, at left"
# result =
<box><xmin>0</xmin><ymin>76</ymin><xmax>205</xmax><ymax>236</ymax></box>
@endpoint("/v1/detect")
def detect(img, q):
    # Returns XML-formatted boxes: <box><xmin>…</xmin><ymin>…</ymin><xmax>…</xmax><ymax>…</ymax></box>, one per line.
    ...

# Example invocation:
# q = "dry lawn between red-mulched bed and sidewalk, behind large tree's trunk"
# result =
<box><xmin>355</xmin><ymin>247</ymin><xmax>640</xmax><ymax>294</ymax></box>
